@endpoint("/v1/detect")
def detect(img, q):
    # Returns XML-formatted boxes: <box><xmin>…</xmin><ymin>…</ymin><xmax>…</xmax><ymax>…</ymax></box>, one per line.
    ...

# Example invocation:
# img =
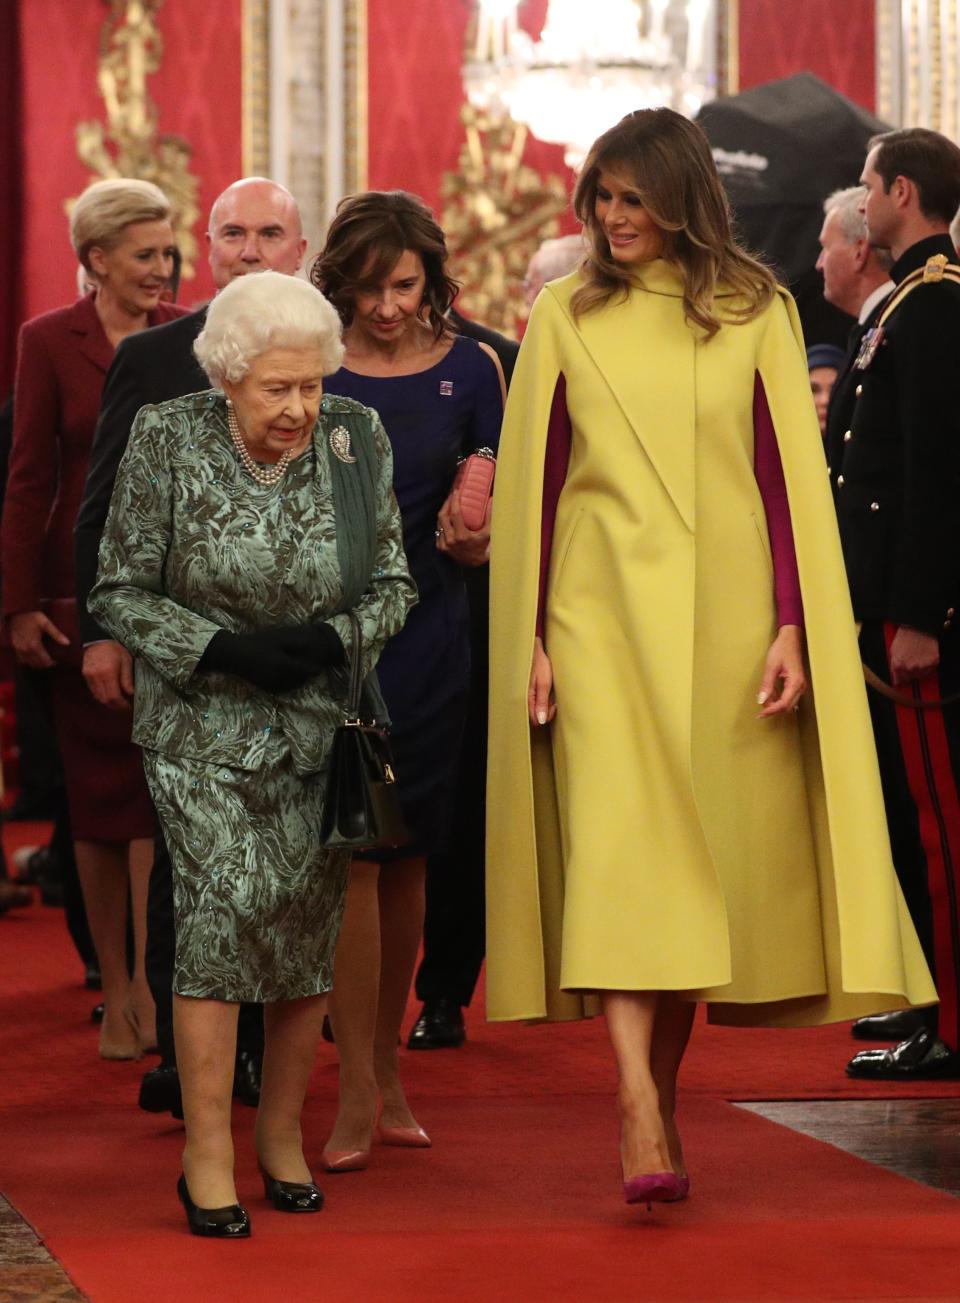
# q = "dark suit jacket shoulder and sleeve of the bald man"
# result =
<box><xmin>76</xmin><ymin>299</ymin><xmax>210</xmax><ymax>642</ymax></box>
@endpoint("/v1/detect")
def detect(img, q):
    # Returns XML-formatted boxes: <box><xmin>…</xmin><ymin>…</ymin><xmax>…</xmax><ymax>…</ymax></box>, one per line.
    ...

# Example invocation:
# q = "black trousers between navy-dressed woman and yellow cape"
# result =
<box><xmin>416</xmin><ymin>566</ymin><xmax>490</xmax><ymax>1005</ymax></box>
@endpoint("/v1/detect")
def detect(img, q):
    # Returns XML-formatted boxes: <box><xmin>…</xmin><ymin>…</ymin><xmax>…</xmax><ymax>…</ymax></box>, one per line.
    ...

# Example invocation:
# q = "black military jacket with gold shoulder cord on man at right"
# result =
<box><xmin>831</xmin><ymin>236</ymin><xmax>960</xmax><ymax>637</ymax></box>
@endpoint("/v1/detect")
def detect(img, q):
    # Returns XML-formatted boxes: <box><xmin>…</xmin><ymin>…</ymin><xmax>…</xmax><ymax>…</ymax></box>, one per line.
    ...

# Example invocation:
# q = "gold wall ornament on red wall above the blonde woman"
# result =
<box><xmin>74</xmin><ymin>0</ymin><xmax>199</xmax><ymax>280</ymax></box>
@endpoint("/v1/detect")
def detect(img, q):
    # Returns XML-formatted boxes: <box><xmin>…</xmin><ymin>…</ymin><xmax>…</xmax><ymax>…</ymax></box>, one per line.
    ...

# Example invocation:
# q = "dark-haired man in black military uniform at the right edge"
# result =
<box><xmin>830</xmin><ymin>128</ymin><xmax>960</xmax><ymax>1080</ymax></box>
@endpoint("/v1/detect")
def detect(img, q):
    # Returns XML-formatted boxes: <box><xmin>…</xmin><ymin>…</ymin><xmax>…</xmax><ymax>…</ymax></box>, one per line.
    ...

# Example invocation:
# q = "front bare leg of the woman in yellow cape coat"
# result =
<box><xmin>600</xmin><ymin>990</ymin><xmax>671</xmax><ymax>1179</ymax></box>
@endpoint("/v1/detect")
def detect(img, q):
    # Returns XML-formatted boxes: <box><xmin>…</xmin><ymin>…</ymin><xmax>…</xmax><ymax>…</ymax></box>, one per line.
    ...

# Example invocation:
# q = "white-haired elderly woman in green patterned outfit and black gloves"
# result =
<box><xmin>90</xmin><ymin>271</ymin><xmax>416</xmax><ymax>1237</ymax></box>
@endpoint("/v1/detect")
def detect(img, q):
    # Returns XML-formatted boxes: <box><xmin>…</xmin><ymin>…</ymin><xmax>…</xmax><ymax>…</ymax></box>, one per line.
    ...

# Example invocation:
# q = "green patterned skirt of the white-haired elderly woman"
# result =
<box><xmin>143</xmin><ymin>730</ymin><xmax>349</xmax><ymax>1002</ymax></box>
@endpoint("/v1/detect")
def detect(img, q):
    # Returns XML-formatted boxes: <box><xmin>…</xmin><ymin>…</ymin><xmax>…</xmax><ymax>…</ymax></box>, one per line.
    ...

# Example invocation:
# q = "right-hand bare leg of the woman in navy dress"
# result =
<box><xmin>374</xmin><ymin>857</ymin><xmax>426</xmax><ymax>1127</ymax></box>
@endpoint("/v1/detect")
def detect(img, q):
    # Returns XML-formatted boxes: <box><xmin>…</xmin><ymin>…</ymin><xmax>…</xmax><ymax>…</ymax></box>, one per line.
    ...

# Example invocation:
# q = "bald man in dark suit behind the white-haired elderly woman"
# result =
<box><xmin>76</xmin><ymin>170</ymin><xmax>306</xmax><ymax>1115</ymax></box>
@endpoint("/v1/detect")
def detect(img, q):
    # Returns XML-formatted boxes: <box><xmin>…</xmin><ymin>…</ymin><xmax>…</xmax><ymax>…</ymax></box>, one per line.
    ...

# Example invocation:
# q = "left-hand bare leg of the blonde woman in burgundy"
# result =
<box><xmin>74</xmin><ymin>842</ymin><xmax>141</xmax><ymax>1059</ymax></box>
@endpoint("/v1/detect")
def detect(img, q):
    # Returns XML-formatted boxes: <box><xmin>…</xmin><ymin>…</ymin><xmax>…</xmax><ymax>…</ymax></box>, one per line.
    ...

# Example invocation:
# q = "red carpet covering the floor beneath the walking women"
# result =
<box><xmin>0</xmin><ymin>844</ymin><xmax>960</xmax><ymax>1303</ymax></box>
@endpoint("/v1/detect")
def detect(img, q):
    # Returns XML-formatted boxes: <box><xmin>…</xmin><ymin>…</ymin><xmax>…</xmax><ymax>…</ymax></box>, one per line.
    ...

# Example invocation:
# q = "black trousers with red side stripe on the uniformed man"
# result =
<box><xmin>860</xmin><ymin>620</ymin><xmax>960</xmax><ymax>1050</ymax></box>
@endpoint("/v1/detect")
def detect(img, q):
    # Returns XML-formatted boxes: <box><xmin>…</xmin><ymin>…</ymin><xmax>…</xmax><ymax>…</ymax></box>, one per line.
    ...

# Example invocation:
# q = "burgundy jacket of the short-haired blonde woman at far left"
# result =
<box><xmin>0</xmin><ymin>294</ymin><xmax>184</xmax><ymax>615</ymax></box>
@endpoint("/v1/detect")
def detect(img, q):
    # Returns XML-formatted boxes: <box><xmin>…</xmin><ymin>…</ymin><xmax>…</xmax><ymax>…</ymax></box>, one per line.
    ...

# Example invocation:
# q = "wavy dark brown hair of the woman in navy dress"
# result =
<box><xmin>310</xmin><ymin>190</ymin><xmax>460</xmax><ymax>339</ymax></box>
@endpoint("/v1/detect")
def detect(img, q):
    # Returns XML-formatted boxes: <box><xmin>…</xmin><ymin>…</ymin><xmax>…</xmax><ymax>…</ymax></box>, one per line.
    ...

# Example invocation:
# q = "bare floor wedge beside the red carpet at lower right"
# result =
<box><xmin>740</xmin><ymin>1098</ymin><xmax>960</xmax><ymax>1199</ymax></box>
